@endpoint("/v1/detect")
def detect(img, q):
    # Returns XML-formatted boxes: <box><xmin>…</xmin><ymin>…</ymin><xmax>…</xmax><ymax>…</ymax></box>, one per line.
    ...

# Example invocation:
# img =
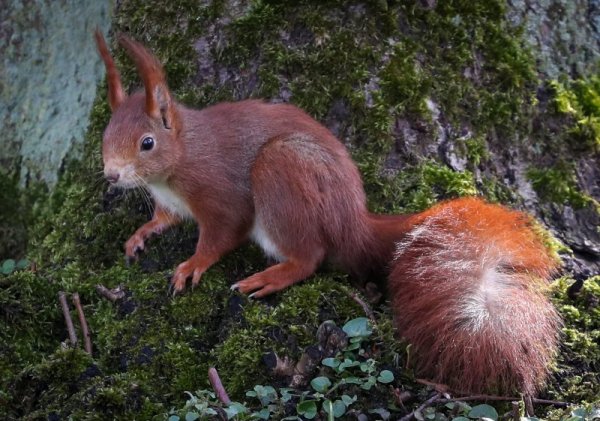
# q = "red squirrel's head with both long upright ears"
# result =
<box><xmin>95</xmin><ymin>30</ymin><xmax>183</xmax><ymax>188</ymax></box>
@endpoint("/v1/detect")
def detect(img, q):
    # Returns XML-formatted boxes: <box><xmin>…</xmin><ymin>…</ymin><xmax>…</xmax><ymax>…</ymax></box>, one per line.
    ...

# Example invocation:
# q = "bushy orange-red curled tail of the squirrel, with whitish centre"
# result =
<box><xmin>389</xmin><ymin>198</ymin><xmax>561</xmax><ymax>394</ymax></box>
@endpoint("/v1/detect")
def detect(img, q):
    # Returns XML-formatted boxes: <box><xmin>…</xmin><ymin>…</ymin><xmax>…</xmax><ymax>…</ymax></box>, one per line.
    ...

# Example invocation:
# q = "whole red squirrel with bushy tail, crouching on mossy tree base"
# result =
<box><xmin>95</xmin><ymin>30</ymin><xmax>560</xmax><ymax>394</ymax></box>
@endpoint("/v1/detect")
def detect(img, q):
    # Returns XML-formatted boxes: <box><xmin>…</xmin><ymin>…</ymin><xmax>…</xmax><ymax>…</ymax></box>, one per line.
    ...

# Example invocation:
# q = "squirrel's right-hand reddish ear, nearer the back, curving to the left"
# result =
<box><xmin>118</xmin><ymin>34</ymin><xmax>176</xmax><ymax>129</ymax></box>
